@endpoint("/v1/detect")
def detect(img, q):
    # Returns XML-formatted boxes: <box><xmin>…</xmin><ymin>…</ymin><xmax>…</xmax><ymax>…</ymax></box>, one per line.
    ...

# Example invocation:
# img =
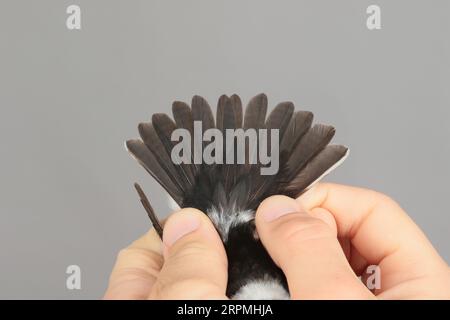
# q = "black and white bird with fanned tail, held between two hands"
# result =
<box><xmin>126</xmin><ymin>94</ymin><xmax>348</xmax><ymax>299</ymax></box>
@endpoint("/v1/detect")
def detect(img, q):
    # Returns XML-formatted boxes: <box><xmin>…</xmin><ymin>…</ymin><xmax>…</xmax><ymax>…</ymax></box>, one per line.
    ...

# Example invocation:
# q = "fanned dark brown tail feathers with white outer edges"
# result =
<box><xmin>127</xmin><ymin>94</ymin><xmax>348</xmax><ymax>214</ymax></box>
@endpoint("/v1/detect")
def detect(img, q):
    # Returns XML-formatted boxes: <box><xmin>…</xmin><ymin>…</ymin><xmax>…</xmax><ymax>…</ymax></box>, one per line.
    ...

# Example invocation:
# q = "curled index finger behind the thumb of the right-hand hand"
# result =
<box><xmin>298</xmin><ymin>183</ymin><xmax>447</xmax><ymax>291</ymax></box>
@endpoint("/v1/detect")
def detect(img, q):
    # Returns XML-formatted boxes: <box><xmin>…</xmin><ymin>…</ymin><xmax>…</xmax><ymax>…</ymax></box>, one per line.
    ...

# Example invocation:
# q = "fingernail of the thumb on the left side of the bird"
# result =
<box><xmin>163</xmin><ymin>212</ymin><xmax>200</xmax><ymax>247</ymax></box>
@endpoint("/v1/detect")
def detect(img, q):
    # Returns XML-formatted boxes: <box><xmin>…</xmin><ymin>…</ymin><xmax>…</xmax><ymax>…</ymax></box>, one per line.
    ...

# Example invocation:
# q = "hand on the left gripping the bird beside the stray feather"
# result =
<box><xmin>104</xmin><ymin>209</ymin><xmax>228</xmax><ymax>299</ymax></box>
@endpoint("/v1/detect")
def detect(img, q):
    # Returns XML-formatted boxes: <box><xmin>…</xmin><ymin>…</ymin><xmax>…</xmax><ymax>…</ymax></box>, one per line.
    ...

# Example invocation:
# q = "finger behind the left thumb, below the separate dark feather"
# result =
<box><xmin>104</xmin><ymin>229</ymin><xmax>163</xmax><ymax>299</ymax></box>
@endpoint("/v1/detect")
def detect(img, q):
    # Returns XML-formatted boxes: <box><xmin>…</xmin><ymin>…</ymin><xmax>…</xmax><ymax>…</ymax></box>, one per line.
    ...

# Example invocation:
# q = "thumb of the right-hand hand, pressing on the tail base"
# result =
<box><xmin>256</xmin><ymin>196</ymin><xmax>373</xmax><ymax>299</ymax></box>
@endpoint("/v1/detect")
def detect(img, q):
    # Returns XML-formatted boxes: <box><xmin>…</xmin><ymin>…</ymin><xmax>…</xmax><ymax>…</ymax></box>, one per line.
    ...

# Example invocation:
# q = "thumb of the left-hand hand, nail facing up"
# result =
<box><xmin>150</xmin><ymin>209</ymin><xmax>228</xmax><ymax>299</ymax></box>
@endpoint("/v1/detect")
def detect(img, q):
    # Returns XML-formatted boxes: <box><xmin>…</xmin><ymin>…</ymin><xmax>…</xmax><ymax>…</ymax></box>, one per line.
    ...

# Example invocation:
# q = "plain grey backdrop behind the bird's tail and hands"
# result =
<box><xmin>0</xmin><ymin>0</ymin><xmax>450</xmax><ymax>299</ymax></box>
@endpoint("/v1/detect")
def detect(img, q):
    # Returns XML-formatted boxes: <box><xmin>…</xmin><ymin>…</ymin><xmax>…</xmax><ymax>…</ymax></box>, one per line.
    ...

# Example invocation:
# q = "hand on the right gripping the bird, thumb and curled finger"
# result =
<box><xmin>256</xmin><ymin>184</ymin><xmax>450</xmax><ymax>299</ymax></box>
